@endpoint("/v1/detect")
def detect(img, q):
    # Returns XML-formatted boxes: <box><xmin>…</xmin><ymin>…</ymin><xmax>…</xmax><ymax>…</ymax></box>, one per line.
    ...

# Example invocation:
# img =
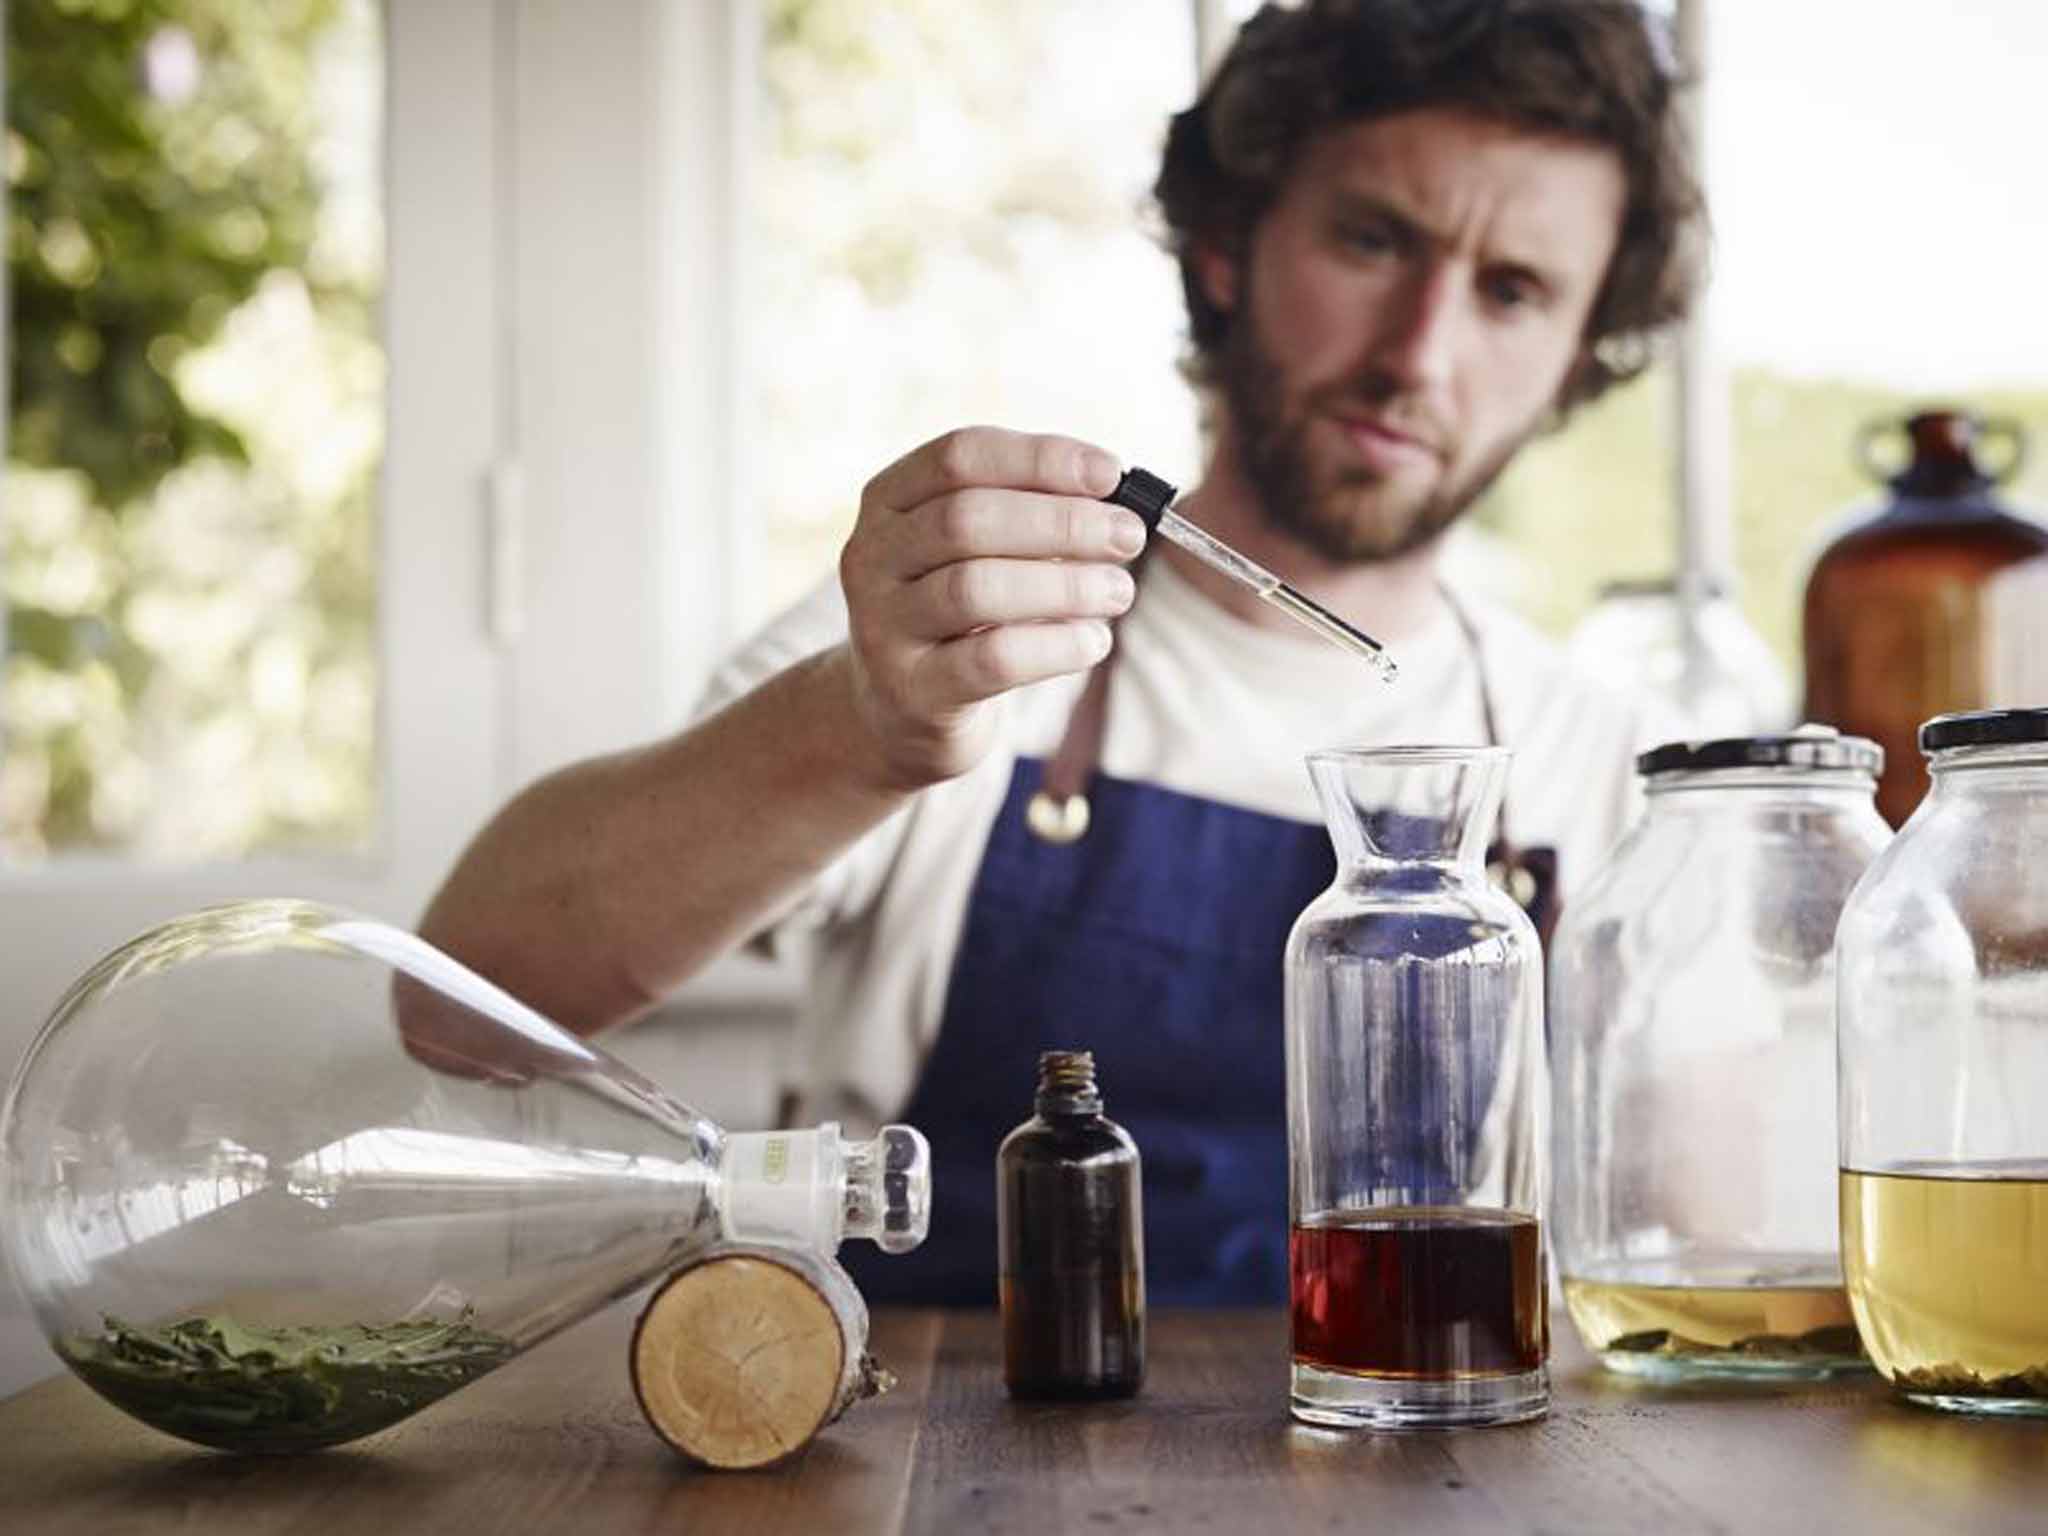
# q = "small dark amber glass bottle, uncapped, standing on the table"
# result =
<box><xmin>995</xmin><ymin>1051</ymin><xmax>1145</xmax><ymax>1399</ymax></box>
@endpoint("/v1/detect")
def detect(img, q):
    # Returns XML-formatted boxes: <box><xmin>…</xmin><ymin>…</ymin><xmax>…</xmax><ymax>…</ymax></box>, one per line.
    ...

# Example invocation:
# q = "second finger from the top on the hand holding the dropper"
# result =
<box><xmin>887</xmin><ymin>487</ymin><xmax>1145</xmax><ymax>582</ymax></box>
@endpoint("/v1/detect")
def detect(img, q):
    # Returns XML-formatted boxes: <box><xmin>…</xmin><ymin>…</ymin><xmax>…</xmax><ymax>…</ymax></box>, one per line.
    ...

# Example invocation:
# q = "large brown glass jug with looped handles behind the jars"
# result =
<box><xmin>1804</xmin><ymin>410</ymin><xmax>2048</xmax><ymax>827</ymax></box>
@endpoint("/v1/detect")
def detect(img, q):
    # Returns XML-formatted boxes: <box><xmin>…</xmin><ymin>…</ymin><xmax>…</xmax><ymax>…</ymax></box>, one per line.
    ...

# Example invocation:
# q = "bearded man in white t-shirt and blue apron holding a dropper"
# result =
<box><xmin>424</xmin><ymin>0</ymin><xmax>1700</xmax><ymax>1303</ymax></box>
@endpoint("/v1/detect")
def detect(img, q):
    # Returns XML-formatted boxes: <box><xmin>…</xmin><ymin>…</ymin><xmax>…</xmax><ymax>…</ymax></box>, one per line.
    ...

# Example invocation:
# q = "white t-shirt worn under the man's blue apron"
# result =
<box><xmin>698</xmin><ymin>559</ymin><xmax>1661</xmax><ymax>1126</ymax></box>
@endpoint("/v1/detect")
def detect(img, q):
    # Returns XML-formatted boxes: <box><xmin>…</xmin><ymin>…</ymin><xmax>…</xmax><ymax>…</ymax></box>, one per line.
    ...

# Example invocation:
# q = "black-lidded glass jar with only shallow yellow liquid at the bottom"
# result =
<box><xmin>1550</xmin><ymin>727</ymin><xmax>1890</xmax><ymax>1380</ymax></box>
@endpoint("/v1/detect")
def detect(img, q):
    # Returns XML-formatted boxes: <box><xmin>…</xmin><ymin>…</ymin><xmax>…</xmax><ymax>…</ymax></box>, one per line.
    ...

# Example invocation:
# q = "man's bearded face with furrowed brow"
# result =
<box><xmin>1204</xmin><ymin>109</ymin><xmax>1624</xmax><ymax>563</ymax></box>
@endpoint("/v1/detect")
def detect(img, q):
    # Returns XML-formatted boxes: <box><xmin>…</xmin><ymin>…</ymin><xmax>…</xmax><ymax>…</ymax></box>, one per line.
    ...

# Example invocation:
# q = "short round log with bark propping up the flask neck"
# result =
<box><xmin>633</xmin><ymin>1249</ymin><xmax>872</xmax><ymax>1468</ymax></box>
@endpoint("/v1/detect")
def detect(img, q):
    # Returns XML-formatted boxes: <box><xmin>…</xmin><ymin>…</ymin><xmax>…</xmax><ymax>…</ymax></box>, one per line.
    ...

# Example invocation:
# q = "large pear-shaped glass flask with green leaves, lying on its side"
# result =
<box><xmin>0</xmin><ymin>901</ymin><xmax>930</xmax><ymax>1450</ymax></box>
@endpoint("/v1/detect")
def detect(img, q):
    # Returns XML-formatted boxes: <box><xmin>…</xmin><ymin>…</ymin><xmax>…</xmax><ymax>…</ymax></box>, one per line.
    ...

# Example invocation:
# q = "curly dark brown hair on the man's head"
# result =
<box><xmin>1153</xmin><ymin>0</ymin><xmax>1706</xmax><ymax>414</ymax></box>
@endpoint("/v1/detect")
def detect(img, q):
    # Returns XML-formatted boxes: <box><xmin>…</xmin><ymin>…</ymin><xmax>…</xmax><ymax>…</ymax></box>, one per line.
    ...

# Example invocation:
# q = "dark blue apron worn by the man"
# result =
<box><xmin>840</xmin><ymin>758</ymin><xmax>1335</xmax><ymax>1307</ymax></box>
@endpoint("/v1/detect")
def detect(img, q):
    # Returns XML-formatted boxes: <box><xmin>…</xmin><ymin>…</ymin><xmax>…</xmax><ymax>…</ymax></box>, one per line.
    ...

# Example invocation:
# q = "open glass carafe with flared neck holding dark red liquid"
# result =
<box><xmin>1286</xmin><ymin>748</ymin><xmax>1550</xmax><ymax>1430</ymax></box>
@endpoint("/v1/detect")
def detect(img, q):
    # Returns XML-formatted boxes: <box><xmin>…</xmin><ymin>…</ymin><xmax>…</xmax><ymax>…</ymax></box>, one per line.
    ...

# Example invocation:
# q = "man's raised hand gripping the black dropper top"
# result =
<box><xmin>840</xmin><ymin>426</ymin><xmax>1145</xmax><ymax>788</ymax></box>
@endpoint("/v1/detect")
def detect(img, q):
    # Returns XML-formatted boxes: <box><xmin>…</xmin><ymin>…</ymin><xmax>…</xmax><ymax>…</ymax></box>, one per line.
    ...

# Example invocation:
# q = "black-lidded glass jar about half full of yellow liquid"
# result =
<box><xmin>1837</xmin><ymin>709</ymin><xmax>2048</xmax><ymax>1415</ymax></box>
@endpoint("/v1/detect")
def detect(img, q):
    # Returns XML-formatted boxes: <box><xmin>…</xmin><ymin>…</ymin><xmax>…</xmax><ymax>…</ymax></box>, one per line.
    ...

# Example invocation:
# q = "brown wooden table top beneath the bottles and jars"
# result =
<box><xmin>0</xmin><ymin>1303</ymin><xmax>2048</xmax><ymax>1536</ymax></box>
